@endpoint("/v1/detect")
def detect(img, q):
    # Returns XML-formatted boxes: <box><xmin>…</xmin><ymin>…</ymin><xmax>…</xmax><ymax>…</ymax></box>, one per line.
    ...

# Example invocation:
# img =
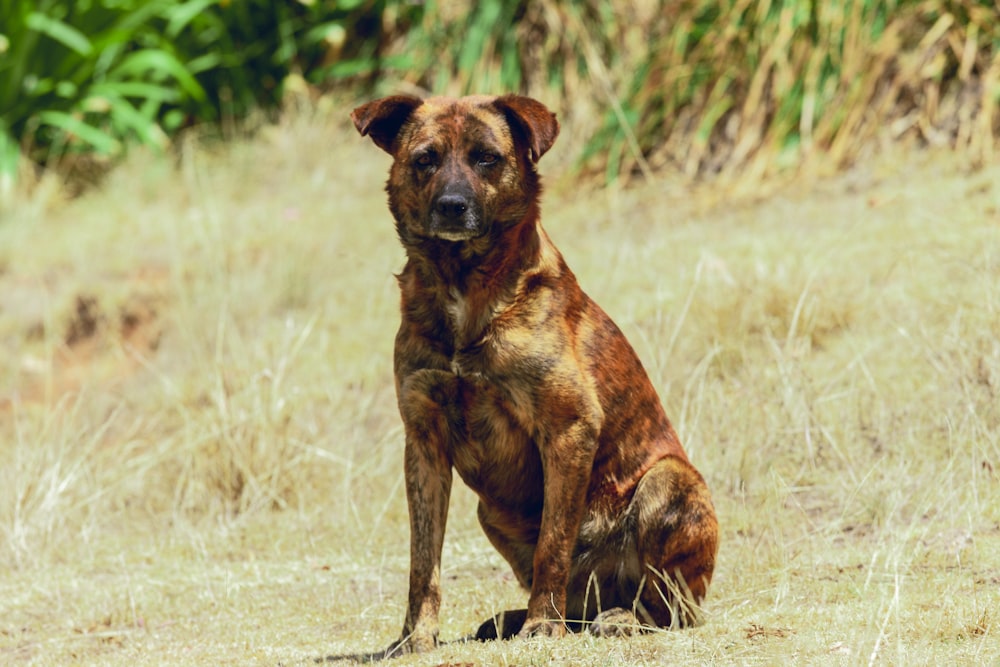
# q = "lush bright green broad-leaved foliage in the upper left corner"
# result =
<box><xmin>0</xmin><ymin>0</ymin><xmax>406</xmax><ymax>185</ymax></box>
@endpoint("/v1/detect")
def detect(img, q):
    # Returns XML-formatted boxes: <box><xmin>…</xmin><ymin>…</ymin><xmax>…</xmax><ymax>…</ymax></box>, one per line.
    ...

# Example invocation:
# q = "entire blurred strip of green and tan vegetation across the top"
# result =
<box><xmin>0</xmin><ymin>0</ymin><xmax>1000</xmax><ymax>196</ymax></box>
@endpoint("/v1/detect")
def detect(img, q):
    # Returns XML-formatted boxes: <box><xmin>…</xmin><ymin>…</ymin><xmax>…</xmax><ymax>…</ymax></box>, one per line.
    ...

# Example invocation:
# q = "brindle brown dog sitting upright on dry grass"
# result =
<box><xmin>351</xmin><ymin>95</ymin><xmax>718</xmax><ymax>654</ymax></box>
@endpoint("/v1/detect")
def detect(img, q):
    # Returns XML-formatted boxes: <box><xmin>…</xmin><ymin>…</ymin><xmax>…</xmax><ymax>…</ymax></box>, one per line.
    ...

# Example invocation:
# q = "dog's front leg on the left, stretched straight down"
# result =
<box><xmin>386</xmin><ymin>371</ymin><xmax>456</xmax><ymax>656</ymax></box>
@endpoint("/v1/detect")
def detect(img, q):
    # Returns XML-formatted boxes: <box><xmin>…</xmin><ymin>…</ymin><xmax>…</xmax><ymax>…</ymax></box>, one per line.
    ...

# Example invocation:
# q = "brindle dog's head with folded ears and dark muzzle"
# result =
<box><xmin>351</xmin><ymin>95</ymin><xmax>559</xmax><ymax>243</ymax></box>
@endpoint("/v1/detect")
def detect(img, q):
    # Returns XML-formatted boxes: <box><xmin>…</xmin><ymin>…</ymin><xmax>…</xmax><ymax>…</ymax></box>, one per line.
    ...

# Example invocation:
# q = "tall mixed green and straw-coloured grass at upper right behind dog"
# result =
<box><xmin>384</xmin><ymin>0</ymin><xmax>1000</xmax><ymax>178</ymax></box>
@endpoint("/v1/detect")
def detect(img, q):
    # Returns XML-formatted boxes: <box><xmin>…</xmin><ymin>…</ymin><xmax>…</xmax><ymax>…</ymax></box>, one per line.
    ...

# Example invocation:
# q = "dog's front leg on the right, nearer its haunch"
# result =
<box><xmin>519</xmin><ymin>419</ymin><xmax>596</xmax><ymax>637</ymax></box>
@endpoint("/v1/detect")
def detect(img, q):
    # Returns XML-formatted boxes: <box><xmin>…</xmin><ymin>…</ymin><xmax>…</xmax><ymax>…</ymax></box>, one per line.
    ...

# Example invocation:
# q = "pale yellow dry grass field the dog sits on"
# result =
<box><xmin>0</xmin><ymin>105</ymin><xmax>1000</xmax><ymax>667</ymax></box>
